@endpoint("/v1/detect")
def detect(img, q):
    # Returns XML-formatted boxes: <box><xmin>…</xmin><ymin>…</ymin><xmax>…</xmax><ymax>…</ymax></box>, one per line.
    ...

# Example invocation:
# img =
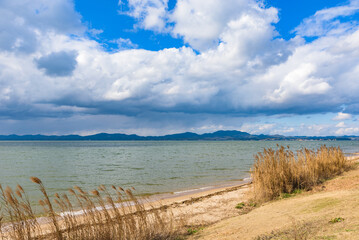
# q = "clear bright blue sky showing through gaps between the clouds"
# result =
<box><xmin>75</xmin><ymin>0</ymin><xmax>347</xmax><ymax>47</ymax></box>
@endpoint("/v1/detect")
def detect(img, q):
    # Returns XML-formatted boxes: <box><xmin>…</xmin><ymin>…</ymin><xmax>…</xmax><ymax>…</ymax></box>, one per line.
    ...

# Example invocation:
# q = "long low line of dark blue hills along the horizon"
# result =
<box><xmin>0</xmin><ymin>130</ymin><xmax>359</xmax><ymax>141</ymax></box>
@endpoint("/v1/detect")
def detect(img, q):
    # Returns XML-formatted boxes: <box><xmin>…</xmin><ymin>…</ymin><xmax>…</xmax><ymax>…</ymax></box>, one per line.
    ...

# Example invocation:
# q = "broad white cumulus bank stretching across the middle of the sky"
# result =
<box><xmin>3</xmin><ymin>1</ymin><xmax>359</xmax><ymax>118</ymax></box>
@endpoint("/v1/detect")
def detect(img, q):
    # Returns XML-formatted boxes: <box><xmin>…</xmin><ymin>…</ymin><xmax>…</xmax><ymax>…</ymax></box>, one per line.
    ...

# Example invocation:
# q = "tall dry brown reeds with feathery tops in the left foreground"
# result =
<box><xmin>0</xmin><ymin>177</ymin><xmax>181</xmax><ymax>240</ymax></box>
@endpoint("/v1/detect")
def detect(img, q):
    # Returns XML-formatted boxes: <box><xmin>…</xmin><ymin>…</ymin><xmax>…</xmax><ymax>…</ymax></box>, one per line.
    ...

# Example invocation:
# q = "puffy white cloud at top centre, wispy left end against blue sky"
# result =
<box><xmin>119</xmin><ymin>0</ymin><xmax>278</xmax><ymax>52</ymax></box>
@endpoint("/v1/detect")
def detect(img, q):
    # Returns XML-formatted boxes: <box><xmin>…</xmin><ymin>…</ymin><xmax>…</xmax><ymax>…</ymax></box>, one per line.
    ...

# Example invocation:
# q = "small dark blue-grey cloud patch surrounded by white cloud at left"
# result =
<box><xmin>35</xmin><ymin>51</ymin><xmax>77</xmax><ymax>77</ymax></box>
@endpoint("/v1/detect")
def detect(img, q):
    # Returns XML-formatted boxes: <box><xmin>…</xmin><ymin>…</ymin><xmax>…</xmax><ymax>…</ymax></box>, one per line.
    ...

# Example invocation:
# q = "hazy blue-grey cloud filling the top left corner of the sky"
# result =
<box><xmin>0</xmin><ymin>0</ymin><xmax>85</xmax><ymax>53</ymax></box>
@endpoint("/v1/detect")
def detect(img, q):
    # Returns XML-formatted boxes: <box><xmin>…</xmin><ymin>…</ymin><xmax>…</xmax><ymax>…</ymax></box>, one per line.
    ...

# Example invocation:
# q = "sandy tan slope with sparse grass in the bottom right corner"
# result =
<box><xmin>188</xmin><ymin>156</ymin><xmax>359</xmax><ymax>240</ymax></box>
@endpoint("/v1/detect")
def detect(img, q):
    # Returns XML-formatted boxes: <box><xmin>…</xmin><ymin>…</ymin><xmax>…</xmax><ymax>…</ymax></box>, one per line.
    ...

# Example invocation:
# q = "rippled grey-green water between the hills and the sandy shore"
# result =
<box><xmin>0</xmin><ymin>141</ymin><xmax>359</xmax><ymax>201</ymax></box>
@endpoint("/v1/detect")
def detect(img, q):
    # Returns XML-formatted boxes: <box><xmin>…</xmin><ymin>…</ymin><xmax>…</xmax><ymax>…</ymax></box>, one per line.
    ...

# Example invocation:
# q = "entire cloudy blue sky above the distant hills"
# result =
<box><xmin>0</xmin><ymin>0</ymin><xmax>359</xmax><ymax>136</ymax></box>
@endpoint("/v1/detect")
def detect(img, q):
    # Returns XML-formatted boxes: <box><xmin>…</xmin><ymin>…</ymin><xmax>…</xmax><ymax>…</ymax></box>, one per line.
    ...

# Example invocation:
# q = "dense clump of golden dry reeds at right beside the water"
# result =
<box><xmin>252</xmin><ymin>146</ymin><xmax>353</xmax><ymax>202</ymax></box>
